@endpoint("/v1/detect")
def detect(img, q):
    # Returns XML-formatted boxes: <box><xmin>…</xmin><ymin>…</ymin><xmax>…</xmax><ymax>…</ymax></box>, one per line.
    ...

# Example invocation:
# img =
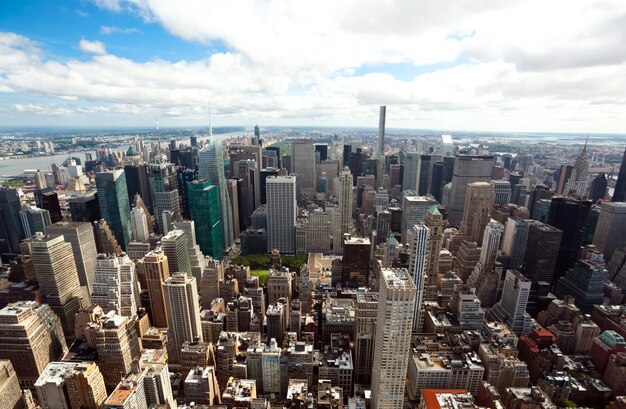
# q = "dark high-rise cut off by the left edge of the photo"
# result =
<box><xmin>0</xmin><ymin>188</ymin><xmax>25</xmax><ymax>254</ymax></box>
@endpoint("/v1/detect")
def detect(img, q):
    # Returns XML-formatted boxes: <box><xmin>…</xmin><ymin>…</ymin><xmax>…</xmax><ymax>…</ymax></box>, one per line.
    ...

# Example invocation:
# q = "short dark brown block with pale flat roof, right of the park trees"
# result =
<box><xmin>341</xmin><ymin>237</ymin><xmax>371</xmax><ymax>287</ymax></box>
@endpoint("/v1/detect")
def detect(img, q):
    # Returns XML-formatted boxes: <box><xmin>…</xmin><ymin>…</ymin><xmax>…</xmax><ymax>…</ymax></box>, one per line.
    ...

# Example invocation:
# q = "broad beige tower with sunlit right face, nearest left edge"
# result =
<box><xmin>31</xmin><ymin>233</ymin><xmax>82</xmax><ymax>339</ymax></box>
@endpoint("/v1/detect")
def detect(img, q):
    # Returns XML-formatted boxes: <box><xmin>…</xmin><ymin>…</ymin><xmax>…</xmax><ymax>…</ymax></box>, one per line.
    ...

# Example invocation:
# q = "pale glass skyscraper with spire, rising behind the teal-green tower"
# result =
<box><xmin>198</xmin><ymin>141</ymin><xmax>235</xmax><ymax>249</ymax></box>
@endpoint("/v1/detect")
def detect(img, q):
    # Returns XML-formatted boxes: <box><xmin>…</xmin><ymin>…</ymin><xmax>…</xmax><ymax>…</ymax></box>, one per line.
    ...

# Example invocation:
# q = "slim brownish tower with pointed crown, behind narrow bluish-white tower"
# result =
<box><xmin>424</xmin><ymin>205</ymin><xmax>443</xmax><ymax>301</ymax></box>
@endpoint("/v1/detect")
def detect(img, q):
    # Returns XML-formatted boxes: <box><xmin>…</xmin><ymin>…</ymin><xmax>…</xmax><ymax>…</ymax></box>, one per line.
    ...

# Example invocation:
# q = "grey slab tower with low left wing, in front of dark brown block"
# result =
<box><xmin>487</xmin><ymin>269</ymin><xmax>532</xmax><ymax>336</ymax></box>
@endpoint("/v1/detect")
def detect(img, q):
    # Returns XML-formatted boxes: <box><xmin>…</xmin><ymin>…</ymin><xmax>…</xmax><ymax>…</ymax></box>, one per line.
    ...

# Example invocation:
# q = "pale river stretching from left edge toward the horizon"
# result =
<box><xmin>0</xmin><ymin>132</ymin><xmax>249</xmax><ymax>180</ymax></box>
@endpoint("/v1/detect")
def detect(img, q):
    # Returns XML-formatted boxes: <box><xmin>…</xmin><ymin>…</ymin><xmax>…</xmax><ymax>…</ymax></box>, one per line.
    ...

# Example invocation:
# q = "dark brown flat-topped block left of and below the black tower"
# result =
<box><xmin>522</xmin><ymin>222</ymin><xmax>563</xmax><ymax>283</ymax></box>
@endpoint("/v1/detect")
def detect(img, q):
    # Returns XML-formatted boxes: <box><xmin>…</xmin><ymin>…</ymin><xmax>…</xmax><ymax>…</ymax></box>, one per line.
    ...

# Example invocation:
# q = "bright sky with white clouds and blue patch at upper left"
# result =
<box><xmin>0</xmin><ymin>0</ymin><xmax>626</xmax><ymax>134</ymax></box>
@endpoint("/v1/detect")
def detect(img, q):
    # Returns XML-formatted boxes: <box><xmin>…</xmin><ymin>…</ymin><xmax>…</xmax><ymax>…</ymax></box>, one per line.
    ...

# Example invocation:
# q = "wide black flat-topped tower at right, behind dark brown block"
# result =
<box><xmin>548</xmin><ymin>197</ymin><xmax>591</xmax><ymax>277</ymax></box>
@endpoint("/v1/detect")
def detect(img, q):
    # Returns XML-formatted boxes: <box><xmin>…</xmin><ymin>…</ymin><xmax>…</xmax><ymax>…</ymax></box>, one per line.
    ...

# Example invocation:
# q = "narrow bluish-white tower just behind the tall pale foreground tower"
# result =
<box><xmin>407</xmin><ymin>224</ymin><xmax>430</xmax><ymax>333</ymax></box>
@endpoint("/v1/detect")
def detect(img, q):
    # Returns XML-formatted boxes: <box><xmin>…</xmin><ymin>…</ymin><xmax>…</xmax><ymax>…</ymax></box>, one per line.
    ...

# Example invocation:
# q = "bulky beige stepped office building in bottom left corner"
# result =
<box><xmin>0</xmin><ymin>301</ymin><xmax>68</xmax><ymax>388</ymax></box>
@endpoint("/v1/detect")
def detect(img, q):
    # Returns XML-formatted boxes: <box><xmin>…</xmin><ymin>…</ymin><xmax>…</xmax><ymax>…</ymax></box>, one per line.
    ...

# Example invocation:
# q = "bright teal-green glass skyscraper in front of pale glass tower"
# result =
<box><xmin>187</xmin><ymin>180</ymin><xmax>224</xmax><ymax>260</ymax></box>
